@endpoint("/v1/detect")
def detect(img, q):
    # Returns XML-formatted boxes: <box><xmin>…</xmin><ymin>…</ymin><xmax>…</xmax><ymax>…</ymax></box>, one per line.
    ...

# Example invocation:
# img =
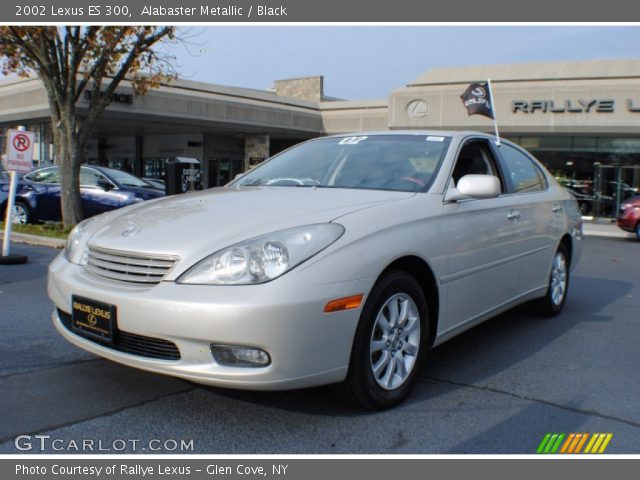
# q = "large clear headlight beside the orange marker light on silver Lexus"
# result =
<box><xmin>178</xmin><ymin>223</ymin><xmax>344</xmax><ymax>285</ymax></box>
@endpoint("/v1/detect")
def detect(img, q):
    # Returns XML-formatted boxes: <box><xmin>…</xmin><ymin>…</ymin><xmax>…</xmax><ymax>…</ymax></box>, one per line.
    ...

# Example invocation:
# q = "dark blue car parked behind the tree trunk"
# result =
<box><xmin>0</xmin><ymin>165</ymin><xmax>164</xmax><ymax>223</ymax></box>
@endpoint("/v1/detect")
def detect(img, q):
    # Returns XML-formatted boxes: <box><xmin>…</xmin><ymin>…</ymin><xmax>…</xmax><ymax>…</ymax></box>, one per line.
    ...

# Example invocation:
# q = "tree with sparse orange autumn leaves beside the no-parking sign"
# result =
<box><xmin>0</xmin><ymin>26</ymin><xmax>175</xmax><ymax>226</ymax></box>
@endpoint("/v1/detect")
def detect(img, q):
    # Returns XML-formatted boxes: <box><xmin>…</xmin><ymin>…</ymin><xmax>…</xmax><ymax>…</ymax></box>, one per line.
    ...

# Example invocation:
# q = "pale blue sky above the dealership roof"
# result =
<box><xmin>169</xmin><ymin>26</ymin><xmax>640</xmax><ymax>100</ymax></box>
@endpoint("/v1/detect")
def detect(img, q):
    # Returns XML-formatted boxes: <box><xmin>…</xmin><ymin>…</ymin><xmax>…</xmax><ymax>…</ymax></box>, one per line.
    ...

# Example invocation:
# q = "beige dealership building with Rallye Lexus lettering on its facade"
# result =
<box><xmin>0</xmin><ymin>59</ymin><xmax>640</xmax><ymax>216</ymax></box>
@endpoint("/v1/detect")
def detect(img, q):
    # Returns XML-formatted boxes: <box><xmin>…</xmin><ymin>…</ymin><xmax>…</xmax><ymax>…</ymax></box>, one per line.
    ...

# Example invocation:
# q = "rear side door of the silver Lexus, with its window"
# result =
<box><xmin>496</xmin><ymin>143</ymin><xmax>564</xmax><ymax>294</ymax></box>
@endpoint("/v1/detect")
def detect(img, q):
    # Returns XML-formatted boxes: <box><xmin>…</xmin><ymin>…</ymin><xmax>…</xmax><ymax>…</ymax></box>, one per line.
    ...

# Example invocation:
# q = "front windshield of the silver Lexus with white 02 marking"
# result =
<box><xmin>230</xmin><ymin>134</ymin><xmax>450</xmax><ymax>192</ymax></box>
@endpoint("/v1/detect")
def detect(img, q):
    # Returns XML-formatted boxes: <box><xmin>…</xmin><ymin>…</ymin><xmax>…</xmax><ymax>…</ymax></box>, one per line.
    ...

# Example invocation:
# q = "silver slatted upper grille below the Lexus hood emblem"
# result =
<box><xmin>87</xmin><ymin>247</ymin><xmax>179</xmax><ymax>285</ymax></box>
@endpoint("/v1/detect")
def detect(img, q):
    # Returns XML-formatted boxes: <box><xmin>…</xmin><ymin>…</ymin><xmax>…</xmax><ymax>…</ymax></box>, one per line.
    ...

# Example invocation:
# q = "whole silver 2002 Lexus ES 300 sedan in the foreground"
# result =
<box><xmin>48</xmin><ymin>132</ymin><xmax>582</xmax><ymax>408</ymax></box>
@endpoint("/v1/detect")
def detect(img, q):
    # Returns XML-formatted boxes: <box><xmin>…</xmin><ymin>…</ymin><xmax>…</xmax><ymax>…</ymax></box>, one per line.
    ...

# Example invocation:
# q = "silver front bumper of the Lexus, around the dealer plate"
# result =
<box><xmin>48</xmin><ymin>254</ymin><xmax>373</xmax><ymax>390</ymax></box>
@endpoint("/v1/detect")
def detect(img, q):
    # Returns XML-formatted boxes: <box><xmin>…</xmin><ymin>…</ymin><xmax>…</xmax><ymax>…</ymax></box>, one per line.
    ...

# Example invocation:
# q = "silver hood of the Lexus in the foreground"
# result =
<box><xmin>87</xmin><ymin>187</ymin><xmax>415</xmax><ymax>274</ymax></box>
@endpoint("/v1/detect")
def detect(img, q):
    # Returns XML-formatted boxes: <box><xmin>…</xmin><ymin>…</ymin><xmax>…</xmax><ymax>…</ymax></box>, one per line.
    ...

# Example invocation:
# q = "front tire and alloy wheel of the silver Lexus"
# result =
<box><xmin>334</xmin><ymin>270</ymin><xmax>429</xmax><ymax>410</ymax></box>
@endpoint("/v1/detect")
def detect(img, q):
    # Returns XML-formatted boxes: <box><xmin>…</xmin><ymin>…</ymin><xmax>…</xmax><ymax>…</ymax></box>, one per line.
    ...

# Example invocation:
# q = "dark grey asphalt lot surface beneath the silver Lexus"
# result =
<box><xmin>0</xmin><ymin>237</ymin><xmax>640</xmax><ymax>454</ymax></box>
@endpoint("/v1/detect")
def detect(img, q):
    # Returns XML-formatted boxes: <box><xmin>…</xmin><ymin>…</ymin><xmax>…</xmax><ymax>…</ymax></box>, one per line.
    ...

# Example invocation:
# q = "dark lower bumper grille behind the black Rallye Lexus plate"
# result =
<box><xmin>58</xmin><ymin>309</ymin><xmax>180</xmax><ymax>360</ymax></box>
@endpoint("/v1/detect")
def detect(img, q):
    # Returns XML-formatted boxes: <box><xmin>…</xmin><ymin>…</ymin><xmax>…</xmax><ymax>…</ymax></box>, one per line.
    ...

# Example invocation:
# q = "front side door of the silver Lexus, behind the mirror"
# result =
<box><xmin>441</xmin><ymin>138</ymin><xmax>520</xmax><ymax>331</ymax></box>
